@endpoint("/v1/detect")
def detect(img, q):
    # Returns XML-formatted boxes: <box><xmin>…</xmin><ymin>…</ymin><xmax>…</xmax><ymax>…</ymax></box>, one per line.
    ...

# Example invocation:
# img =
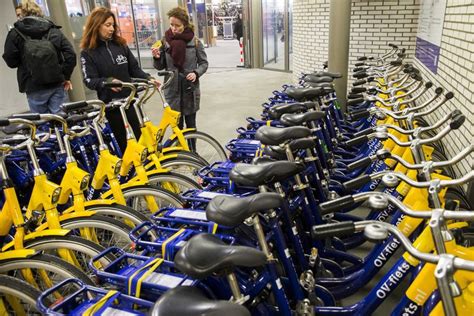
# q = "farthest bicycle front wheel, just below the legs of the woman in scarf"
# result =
<box><xmin>171</xmin><ymin>131</ymin><xmax>227</xmax><ymax>164</ymax></box>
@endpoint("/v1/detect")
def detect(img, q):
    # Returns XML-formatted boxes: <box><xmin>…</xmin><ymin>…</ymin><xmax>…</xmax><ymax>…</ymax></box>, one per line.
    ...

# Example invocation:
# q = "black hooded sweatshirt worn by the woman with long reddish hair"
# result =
<box><xmin>81</xmin><ymin>40</ymin><xmax>151</xmax><ymax>102</ymax></box>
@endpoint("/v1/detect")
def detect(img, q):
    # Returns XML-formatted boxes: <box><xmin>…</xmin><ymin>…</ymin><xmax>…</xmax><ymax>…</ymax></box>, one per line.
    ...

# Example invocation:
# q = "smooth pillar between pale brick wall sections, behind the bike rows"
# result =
<box><xmin>328</xmin><ymin>0</ymin><xmax>351</xmax><ymax>111</ymax></box>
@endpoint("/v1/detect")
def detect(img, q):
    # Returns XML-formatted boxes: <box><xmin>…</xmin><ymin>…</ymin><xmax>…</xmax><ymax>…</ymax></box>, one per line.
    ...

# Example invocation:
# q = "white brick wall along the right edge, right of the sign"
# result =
<box><xmin>414</xmin><ymin>0</ymin><xmax>474</xmax><ymax>175</ymax></box>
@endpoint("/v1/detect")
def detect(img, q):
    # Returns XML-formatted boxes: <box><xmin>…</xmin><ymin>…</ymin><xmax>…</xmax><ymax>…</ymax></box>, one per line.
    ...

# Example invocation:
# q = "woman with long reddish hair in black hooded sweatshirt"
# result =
<box><xmin>81</xmin><ymin>7</ymin><xmax>160</xmax><ymax>152</ymax></box>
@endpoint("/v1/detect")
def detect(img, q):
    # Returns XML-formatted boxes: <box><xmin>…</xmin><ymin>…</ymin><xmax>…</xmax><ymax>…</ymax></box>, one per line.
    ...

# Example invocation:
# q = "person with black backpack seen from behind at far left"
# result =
<box><xmin>3</xmin><ymin>0</ymin><xmax>76</xmax><ymax>113</ymax></box>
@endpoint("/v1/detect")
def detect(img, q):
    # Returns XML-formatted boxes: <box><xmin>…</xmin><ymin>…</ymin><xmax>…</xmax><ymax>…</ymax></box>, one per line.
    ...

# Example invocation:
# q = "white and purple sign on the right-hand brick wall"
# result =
<box><xmin>415</xmin><ymin>0</ymin><xmax>446</xmax><ymax>74</ymax></box>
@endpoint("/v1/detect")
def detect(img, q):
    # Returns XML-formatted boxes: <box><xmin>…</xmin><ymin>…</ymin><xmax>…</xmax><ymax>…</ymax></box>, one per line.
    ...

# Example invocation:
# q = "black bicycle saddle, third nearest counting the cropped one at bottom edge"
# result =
<box><xmin>206</xmin><ymin>193</ymin><xmax>283</xmax><ymax>226</ymax></box>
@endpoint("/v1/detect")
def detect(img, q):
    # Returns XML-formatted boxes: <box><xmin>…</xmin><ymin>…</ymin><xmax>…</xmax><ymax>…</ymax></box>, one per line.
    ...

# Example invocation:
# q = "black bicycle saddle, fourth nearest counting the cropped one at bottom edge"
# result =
<box><xmin>229</xmin><ymin>161</ymin><xmax>304</xmax><ymax>187</ymax></box>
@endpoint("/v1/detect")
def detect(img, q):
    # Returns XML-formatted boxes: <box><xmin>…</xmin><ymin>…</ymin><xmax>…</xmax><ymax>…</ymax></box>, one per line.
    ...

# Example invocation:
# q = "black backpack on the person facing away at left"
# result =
<box><xmin>15</xmin><ymin>28</ymin><xmax>64</xmax><ymax>84</ymax></box>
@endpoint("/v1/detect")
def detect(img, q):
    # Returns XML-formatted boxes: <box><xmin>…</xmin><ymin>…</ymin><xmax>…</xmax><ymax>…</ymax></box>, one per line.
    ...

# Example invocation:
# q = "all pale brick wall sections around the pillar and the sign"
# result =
<box><xmin>294</xmin><ymin>0</ymin><xmax>474</xmax><ymax>175</ymax></box>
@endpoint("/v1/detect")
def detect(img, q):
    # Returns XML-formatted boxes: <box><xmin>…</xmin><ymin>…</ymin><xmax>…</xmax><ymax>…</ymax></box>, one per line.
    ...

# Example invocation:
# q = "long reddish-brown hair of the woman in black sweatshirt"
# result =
<box><xmin>81</xmin><ymin>7</ymin><xmax>127</xmax><ymax>49</ymax></box>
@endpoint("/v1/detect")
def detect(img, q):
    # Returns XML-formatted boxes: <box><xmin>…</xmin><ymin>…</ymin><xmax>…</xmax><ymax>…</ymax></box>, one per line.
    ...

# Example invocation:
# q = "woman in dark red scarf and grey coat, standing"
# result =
<box><xmin>152</xmin><ymin>7</ymin><xmax>208</xmax><ymax>150</ymax></box>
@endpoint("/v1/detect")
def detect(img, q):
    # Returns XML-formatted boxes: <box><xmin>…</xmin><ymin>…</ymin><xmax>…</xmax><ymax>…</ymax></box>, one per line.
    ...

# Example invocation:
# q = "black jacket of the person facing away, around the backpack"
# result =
<box><xmin>3</xmin><ymin>16</ymin><xmax>76</xmax><ymax>92</ymax></box>
